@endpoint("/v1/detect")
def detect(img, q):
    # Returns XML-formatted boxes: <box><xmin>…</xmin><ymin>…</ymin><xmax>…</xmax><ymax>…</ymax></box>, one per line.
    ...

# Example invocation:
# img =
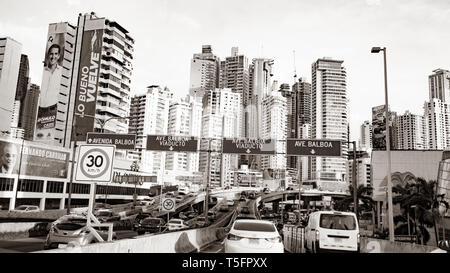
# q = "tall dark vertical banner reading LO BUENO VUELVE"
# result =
<box><xmin>75</xmin><ymin>29</ymin><xmax>103</xmax><ymax>141</ymax></box>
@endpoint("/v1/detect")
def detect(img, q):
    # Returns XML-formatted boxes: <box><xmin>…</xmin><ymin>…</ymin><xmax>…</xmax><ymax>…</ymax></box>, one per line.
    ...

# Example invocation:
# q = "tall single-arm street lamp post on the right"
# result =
<box><xmin>371</xmin><ymin>47</ymin><xmax>395</xmax><ymax>242</ymax></box>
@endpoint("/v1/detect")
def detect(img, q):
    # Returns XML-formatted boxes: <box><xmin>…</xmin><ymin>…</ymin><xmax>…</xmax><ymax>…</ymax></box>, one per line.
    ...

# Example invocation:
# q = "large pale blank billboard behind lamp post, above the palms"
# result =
<box><xmin>371</xmin><ymin>150</ymin><xmax>443</xmax><ymax>201</ymax></box>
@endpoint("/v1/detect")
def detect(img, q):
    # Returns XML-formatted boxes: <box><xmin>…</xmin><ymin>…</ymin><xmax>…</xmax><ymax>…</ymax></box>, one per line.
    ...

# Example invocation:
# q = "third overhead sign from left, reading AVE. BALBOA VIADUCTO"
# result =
<box><xmin>223</xmin><ymin>138</ymin><xmax>275</xmax><ymax>155</ymax></box>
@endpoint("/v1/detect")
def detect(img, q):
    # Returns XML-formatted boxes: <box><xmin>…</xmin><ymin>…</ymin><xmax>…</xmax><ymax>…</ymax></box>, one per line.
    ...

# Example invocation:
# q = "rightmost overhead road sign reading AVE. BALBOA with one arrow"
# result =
<box><xmin>286</xmin><ymin>139</ymin><xmax>342</xmax><ymax>157</ymax></box>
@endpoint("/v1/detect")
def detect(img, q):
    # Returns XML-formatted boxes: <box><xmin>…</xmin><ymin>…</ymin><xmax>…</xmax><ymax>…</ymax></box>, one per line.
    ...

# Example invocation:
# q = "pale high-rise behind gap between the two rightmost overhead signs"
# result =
<box><xmin>261</xmin><ymin>92</ymin><xmax>288</xmax><ymax>170</ymax></box>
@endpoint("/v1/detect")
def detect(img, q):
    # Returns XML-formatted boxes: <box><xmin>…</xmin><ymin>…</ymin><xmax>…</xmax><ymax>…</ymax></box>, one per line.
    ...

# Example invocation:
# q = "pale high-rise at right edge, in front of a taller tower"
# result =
<box><xmin>424</xmin><ymin>99</ymin><xmax>450</xmax><ymax>150</ymax></box>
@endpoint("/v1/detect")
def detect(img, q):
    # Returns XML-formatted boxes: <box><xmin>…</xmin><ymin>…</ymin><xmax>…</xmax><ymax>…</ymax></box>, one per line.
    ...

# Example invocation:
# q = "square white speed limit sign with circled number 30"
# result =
<box><xmin>75</xmin><ymin>145</ymin><xmax>115</xmax><ymax>182</ymax></box>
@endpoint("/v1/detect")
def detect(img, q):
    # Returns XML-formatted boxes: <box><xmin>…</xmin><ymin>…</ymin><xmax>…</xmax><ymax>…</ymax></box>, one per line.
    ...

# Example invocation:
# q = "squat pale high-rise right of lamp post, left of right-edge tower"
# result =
<box><xmin>395</xmin><ymin>111</ymin><xmax>427</xmax><ymax>150</ymax></box>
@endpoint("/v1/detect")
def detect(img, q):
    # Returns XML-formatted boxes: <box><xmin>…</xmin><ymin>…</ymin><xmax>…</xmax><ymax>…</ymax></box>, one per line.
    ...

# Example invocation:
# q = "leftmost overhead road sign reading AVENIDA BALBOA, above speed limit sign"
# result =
<box><xmin>86</xmin><ymin>133</ymin><xmax>136</xmax><ymax>150</ymax></box>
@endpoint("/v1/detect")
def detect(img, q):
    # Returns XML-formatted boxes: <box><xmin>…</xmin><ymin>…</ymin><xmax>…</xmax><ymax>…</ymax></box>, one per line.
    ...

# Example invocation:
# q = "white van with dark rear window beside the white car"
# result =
<box><xmin>305</xmin><ymin>211</ymin><xmax>360</xmax><ymax>253</ymax></box>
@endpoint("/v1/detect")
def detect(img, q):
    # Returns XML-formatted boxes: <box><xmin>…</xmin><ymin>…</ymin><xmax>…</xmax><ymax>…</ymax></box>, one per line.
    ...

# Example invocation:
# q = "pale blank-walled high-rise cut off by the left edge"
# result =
<box><xmin>0</xmin><ymin>37</ymin><xmax>22</xmax><ymax>135</ymax></box>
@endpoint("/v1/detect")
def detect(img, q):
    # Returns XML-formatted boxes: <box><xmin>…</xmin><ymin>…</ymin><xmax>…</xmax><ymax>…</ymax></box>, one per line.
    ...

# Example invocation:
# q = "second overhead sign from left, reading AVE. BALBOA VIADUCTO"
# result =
<box><xmin>147</xmin><ymin>135</ymin><xmax>198</xmax><ymax>153</ymax></box>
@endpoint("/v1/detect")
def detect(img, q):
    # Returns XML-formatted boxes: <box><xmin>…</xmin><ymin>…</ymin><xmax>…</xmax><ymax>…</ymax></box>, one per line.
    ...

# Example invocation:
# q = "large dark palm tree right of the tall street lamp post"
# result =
<box><xmin>392</xmin><ymin>178</ymin><xmax>448</xmax><ymax>244</ymax></box>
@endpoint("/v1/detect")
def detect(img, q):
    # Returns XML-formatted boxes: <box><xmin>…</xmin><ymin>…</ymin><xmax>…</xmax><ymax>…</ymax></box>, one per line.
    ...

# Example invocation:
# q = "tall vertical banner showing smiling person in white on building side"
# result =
<box><xmin>35</xmin><ymin>32</ymin><xmax>65</xmax><ymax>144</ymax></box>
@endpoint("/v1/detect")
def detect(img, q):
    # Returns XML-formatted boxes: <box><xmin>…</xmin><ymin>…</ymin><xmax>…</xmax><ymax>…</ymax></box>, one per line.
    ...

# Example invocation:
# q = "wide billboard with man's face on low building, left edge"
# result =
<box><xmin>0</xmin><ymin>137</ymin><xmax>70</xmax><ymax>178</ymax></box>
